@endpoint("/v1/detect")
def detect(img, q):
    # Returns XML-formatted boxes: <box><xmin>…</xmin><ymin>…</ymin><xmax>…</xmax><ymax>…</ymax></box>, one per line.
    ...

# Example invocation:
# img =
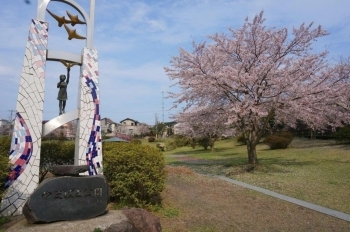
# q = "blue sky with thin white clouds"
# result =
<box><xmin>0</xmin><ymin>0</ymin><xmax>350</xmax><ymax>125</ymax></box>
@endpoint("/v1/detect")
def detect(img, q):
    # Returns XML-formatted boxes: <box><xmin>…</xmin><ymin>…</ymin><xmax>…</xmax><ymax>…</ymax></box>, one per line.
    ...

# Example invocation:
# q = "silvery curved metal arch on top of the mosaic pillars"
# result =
<box><xmin>37</xmin><ymin>0</ymin><xmax>95</xmax><ymax>48</ymax></box>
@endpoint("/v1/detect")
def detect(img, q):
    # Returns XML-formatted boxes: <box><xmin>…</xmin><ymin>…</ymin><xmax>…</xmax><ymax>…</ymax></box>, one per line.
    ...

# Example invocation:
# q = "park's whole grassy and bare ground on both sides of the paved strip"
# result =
<box><xmin>155</xmin><ymin>139</ymin><xmax>350</xmax><ymax>232</ymax></box>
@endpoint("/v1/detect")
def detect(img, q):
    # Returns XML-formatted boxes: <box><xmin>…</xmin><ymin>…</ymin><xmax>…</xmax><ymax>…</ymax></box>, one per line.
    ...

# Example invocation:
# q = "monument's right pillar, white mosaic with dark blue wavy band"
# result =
<box><xmin>75</xmin><ymin>48</ymin><xmax>102</xmax><ymax>175</ymax></box>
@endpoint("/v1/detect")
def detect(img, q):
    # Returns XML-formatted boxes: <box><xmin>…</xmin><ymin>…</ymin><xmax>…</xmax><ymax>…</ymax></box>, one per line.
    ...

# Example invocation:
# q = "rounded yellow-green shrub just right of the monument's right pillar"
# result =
<box><xmin>103</xmin><ymin>143</ymin><xmax>165</xmax><ymax>207</ymax></box>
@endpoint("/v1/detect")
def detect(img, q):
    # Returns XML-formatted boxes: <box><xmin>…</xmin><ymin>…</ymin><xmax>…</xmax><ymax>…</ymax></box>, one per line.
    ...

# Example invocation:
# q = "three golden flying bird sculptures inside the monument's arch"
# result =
<box><xmin>46</xmin><ymin>9</ymin><xmax>86</xmax><ymax>40</ymax></box>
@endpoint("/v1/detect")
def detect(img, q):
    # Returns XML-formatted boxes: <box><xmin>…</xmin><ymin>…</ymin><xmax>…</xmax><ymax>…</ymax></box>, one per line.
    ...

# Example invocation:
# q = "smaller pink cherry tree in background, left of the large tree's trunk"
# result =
<box><xmin>176</xmin><ymin>108</ymin><xmax>235</xmax><ymax>151</ymax></box>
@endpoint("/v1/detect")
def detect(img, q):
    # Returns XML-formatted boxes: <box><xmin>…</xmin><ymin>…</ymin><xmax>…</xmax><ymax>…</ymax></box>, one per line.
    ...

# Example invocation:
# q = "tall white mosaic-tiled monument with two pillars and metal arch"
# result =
<box><xmin>0</xmin><ymin>0</ymin><xmax>102</xmax><ymax>216</ymax></box>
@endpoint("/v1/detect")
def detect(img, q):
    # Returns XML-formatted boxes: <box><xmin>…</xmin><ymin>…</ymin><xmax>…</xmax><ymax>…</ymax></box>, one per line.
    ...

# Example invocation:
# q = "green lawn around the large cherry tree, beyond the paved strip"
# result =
<box><xmin>164</xmin><ymin>139</ymin><xmax>350</xmax><ymax>213</ymax></box>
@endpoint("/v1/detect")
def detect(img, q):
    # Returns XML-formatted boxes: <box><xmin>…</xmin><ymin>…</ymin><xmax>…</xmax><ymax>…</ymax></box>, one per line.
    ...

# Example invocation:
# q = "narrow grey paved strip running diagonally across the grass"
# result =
<box><xmin>214</xmin><ymin>175</ymin><xmax>350</xmax><ymax>222</ymax></box>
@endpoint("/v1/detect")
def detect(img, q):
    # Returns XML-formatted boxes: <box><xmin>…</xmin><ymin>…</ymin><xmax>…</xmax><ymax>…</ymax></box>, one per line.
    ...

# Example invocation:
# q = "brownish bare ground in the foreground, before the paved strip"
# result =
<box><xmin>158</xmin><ymin>167</ymin><xmax>350</xmax><ymax>232</ymax></box>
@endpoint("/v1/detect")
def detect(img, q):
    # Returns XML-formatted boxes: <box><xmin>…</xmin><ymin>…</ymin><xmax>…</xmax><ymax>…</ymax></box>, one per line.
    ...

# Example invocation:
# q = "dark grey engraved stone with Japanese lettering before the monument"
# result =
<box><xmin>23</xmin><ymin>175</ymin><xmax>109</xmax><ymax>223</ymax></box>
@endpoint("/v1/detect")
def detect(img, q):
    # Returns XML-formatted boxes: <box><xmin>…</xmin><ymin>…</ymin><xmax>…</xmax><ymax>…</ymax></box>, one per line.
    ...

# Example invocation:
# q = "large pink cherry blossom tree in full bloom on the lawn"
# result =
<box><xmin>165</xmin><ymin>12</ymin><xmax>350</xmax><ymax>165</ymax></box>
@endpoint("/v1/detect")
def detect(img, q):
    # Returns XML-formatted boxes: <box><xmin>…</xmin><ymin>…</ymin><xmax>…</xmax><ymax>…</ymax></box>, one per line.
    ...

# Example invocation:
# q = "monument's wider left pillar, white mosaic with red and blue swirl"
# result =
<box><xmin>0</xmin><ymin>20</ymin><xmax>48</xmax><ymax>216</ymax></box>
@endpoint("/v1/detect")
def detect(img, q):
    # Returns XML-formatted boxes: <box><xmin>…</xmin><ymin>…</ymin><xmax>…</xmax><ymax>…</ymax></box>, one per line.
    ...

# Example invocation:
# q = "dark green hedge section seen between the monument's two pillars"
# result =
<box><xmin>39</xmin><ymin>140</ymin><xmax>75</xmax><ymax>182</ymax></box>
